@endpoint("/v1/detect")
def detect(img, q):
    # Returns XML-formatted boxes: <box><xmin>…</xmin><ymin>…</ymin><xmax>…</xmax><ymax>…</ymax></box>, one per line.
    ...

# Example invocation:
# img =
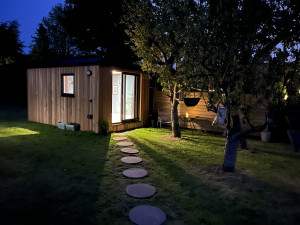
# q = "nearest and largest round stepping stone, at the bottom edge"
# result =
<box><xmin>129</xmin><ymin>205</ymin><xmax>166</xmax><ymax>225</ymax></box>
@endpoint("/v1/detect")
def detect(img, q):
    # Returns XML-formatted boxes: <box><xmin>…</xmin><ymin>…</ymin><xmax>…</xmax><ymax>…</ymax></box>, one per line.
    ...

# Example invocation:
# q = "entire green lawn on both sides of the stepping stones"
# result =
<box><xmin>0</xmin><ymin>111</ymin><xmax>300</xmax><ymax>225</ymax></box>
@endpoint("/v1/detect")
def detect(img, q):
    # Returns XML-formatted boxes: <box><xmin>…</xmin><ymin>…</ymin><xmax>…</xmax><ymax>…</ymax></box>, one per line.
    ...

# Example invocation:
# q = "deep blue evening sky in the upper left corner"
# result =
<box><xmin>0</xmin><ymin>0</ymin><xmax>64</xmax><ymax>53</ymax></box>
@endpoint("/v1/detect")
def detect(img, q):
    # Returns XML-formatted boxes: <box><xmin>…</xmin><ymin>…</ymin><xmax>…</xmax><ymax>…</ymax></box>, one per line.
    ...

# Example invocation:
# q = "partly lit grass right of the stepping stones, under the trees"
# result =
<box><xmin>125</xmin><ymin>129</ymin><xmax>300</xmax><ymax>224</ymax></box>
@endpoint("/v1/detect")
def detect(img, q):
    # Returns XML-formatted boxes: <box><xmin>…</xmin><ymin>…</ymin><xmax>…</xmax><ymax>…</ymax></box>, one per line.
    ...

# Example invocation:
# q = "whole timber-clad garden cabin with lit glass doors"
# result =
<box><xmin>27</xmin><ymin>60</ymin><xmax>149</xmax><ymax>133</ymax></box>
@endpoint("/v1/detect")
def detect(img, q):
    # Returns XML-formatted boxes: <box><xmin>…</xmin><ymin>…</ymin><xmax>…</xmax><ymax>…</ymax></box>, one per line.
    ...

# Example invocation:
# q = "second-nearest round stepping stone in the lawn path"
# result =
<box><xmin>126</xmin><ymin>183</ymin><xmax>156</xmax><ymax>198</ymax></box>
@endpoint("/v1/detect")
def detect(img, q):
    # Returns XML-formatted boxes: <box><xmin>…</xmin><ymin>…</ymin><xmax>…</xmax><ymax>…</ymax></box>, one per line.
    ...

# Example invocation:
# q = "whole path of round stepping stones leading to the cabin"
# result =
<box><xmin>114</xmin><ymin>132</ymin><xmax>166</xmax><ymax>225</ymax></box>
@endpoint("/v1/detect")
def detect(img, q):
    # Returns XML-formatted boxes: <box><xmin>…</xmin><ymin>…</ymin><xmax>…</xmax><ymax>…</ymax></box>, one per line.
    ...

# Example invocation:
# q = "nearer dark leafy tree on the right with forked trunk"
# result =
<box><xmin>184</xmin><ymin>0</ymin><xmax>300</xmax><ymax>171</ymax></box>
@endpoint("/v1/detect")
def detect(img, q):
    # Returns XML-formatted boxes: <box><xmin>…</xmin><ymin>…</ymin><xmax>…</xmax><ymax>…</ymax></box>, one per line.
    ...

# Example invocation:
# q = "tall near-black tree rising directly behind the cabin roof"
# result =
<box><xmin>63</xmin><ymin>0</ymin><xmax>137</xmax><ymax>67</ymax></box>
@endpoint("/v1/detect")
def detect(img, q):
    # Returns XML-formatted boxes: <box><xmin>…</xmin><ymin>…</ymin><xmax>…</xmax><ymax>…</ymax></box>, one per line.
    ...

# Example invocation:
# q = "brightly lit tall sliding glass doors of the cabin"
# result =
<box><xmin>112</xmin><ymin>72</ymin><xmax>139</xmax><ymax>123</ymax></box>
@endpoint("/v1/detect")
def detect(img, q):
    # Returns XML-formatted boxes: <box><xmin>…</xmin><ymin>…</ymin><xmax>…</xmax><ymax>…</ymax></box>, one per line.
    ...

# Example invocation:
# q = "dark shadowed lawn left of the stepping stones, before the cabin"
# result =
<box><xmin>0</xmin><ymin>121</ymin><xmax>110</xmax><ymax>225</ymax></box>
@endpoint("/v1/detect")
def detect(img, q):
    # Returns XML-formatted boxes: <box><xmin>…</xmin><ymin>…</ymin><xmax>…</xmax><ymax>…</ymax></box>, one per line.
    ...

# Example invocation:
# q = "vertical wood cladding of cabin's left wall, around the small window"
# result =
<box><xmin>27</xmin><ymin>66</ymin><xmax>99</xmax><ymax>132</ymax></box>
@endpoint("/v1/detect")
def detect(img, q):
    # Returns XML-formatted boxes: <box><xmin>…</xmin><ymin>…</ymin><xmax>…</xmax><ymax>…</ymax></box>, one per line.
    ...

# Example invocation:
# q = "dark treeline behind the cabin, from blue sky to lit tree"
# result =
<box><xmin>30</xmin><ymin>0</ymin><xmax>137</xmax><ymax>67</ymax></box>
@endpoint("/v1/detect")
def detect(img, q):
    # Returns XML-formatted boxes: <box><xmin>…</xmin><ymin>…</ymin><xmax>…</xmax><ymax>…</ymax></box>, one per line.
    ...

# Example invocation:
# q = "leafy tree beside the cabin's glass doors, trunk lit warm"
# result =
<box><xmin>124</xmin><ymin>0</ymin><xmax>200</xmax><ymax>137</ymax></box>
